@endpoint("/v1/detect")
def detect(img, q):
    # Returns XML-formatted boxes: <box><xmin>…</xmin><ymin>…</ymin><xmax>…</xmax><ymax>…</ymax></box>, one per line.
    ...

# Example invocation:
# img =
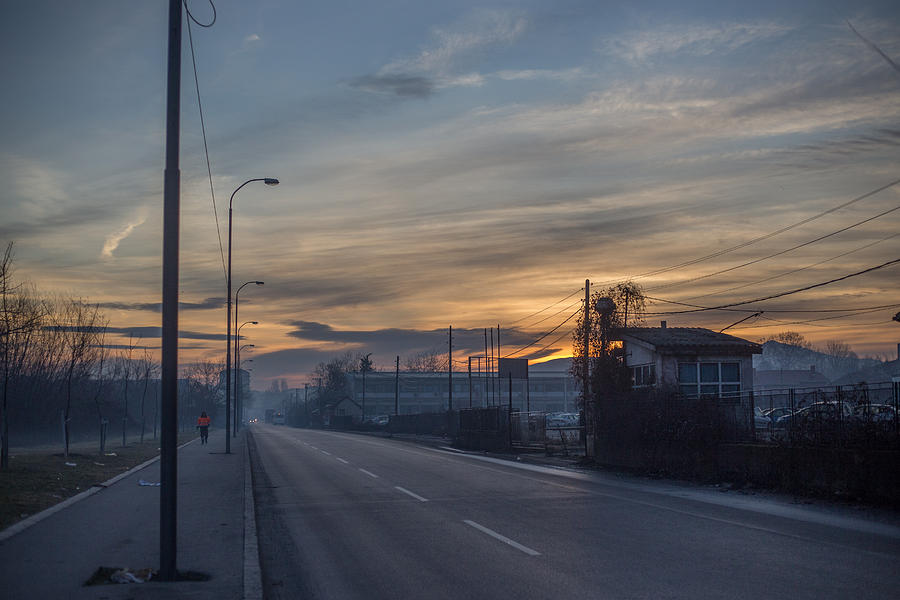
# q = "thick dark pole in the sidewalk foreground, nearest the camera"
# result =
<box><xmin>159</xmin><ymin>0</ymin><xmax>182</xmax><ymax>581</ymax></box>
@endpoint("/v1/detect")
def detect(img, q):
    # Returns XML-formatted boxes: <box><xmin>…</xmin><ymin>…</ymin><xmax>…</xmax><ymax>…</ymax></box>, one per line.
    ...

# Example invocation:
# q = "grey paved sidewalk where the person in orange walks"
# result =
<box><xmin>0</xmin><ymin>430</ymin><xmax>261</xmax><ymax>599</ymax></box>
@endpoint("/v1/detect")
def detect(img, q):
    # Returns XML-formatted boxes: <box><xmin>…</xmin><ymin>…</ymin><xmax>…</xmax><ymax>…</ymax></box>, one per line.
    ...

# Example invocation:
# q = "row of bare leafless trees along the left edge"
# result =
<box><xmin>0</xmin><ymin>243</ymin><xmax>221</xmax><ymax>469</ymax></box>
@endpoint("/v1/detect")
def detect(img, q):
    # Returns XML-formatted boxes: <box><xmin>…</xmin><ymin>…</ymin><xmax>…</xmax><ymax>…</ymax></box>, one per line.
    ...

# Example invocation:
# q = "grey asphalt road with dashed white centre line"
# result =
<box><xmin>251</xmin><ymin>426</ymin><xmax>900</xmax><ymax>600</ymax></box>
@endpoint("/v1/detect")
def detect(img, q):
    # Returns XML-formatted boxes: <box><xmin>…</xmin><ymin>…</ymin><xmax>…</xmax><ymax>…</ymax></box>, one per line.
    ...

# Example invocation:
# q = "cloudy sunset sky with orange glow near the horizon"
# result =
<box><xmin>0</xmin><ymin>0</ymin><xmax>900</xmax><ymax>389</ymax></box>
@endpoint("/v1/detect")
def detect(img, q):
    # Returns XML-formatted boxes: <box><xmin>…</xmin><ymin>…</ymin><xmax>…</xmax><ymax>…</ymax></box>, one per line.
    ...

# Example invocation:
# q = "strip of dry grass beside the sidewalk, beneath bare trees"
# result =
<box><xmin>0</xmin><ymin>432</ymin><xmax>197</xmax><ymax>530</ymax></box>
